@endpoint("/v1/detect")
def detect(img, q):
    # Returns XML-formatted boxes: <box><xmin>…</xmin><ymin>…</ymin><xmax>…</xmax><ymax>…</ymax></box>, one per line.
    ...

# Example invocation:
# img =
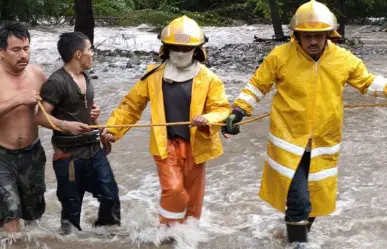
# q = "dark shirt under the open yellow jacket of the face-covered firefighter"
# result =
<box><xmin>163</xmin><ymin>79</ymin><xmax>192</xmax><ymax>141</ymax></box>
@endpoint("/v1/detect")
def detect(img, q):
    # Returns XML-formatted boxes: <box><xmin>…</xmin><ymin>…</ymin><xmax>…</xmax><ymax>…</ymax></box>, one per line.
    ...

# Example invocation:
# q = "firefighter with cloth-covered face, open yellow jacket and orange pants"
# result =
<box><xmin>103</xmin><ymin>16</ymin><xmax>231</xmax><ymax>224</ymax></box>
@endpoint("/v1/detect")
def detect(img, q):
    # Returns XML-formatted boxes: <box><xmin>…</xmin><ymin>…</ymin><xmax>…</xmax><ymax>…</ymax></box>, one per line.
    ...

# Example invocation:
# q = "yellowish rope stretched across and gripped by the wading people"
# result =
<box><xmin>38</xmin><ymin>101</ymin><xmax>387</xmax><ymax>131</ymax></box>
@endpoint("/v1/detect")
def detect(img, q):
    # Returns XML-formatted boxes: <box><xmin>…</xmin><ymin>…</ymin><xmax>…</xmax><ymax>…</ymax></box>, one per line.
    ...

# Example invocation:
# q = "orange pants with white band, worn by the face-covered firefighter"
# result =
<box><xmin>154</xmin><ymin>139</ymin><xmax>205</xmax><ymax>224</ymax></box>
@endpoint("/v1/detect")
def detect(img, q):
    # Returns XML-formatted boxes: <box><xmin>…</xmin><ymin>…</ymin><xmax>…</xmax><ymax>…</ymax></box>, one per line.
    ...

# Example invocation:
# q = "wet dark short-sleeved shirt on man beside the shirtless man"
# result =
<box><xmin>40</xmin><ymin>68</ymin><xmax>100</xmax><ymax>159</ymax></box>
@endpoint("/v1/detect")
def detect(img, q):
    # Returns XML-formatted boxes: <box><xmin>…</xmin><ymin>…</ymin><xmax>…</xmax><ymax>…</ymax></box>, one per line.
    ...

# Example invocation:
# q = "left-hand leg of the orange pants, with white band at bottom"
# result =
<box><xmin>154</xmin><ymin>140</ymin><xmax>189</xmax><ymax>224</ymax></box>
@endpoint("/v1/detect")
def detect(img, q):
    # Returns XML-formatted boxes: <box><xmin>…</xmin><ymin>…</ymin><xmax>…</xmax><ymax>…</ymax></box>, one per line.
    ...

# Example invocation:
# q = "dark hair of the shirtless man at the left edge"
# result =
<box><xmin>0</xmin><ymin>22</ymin><xmax>31</xmax><ymax>49</ymax></box>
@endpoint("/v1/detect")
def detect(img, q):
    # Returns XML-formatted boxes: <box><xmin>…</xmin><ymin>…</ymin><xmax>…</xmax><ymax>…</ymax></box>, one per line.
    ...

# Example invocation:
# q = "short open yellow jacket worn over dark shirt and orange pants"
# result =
<box><xmin>106</xmin><ymin>62</ymin><xmax>231</xmax><ymax>164</ymax></box>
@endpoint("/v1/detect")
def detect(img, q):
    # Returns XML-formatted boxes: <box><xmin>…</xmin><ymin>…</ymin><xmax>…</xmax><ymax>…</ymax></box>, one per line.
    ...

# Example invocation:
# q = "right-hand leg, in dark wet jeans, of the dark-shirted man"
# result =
<box><xmin>88</xmin><ymin>150</ymin><xmax>121</xmax><ymax>226</ymax></box>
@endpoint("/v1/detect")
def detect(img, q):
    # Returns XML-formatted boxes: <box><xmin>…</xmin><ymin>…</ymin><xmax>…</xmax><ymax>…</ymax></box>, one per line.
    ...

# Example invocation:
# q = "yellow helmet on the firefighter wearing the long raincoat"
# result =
<box><xmin>289</xmin><ymin>0</ymin><xmax>341</xmax><ymax>38</ymax></box>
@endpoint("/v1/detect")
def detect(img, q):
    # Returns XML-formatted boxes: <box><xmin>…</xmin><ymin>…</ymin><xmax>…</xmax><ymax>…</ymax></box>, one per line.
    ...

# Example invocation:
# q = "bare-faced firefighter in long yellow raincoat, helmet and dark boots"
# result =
<box><xmin>222</xmin><ymin>0</ymin><xmax>387</xmax><ymax>245</ymax></box>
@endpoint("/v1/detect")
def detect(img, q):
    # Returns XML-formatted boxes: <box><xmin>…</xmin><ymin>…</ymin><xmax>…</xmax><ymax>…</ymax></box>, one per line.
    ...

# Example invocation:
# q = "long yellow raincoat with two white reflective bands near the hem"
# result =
<box><xmin>234</xmin><ymin>40</ymin><xmax>387</xmax><ymax>217</ymax></box>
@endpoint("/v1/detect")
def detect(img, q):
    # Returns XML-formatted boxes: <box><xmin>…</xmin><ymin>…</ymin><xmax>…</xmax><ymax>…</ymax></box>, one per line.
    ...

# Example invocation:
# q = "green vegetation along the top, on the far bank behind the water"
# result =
<box><xmin>0</xmin><ymin>0</ymin><xmax>387</xmax><ymax>26</ymax></box>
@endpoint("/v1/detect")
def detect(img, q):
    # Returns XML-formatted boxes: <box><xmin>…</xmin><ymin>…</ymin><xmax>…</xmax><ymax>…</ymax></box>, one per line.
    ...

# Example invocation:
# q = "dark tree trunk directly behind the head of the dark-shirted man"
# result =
<box><xmin>74</xmin><ymin>0</ymin><xmax>95</xmax><ymax>44</ymax></box>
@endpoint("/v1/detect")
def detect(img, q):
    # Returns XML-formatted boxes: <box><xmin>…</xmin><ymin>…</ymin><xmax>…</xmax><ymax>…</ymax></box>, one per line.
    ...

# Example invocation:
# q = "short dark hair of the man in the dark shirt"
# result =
<box><xmin>57</xmin><ymin>32</ymin><xmax>89</xmax><ymax>63</ymax></box>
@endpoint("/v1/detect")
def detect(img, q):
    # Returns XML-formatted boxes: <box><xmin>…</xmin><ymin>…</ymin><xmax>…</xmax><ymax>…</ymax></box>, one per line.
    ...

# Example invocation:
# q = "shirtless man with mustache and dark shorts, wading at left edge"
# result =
<box><xmin>0</xmin><ymin>22</ymin><xmax>46</xmax><ymax>232</ymax></box>
